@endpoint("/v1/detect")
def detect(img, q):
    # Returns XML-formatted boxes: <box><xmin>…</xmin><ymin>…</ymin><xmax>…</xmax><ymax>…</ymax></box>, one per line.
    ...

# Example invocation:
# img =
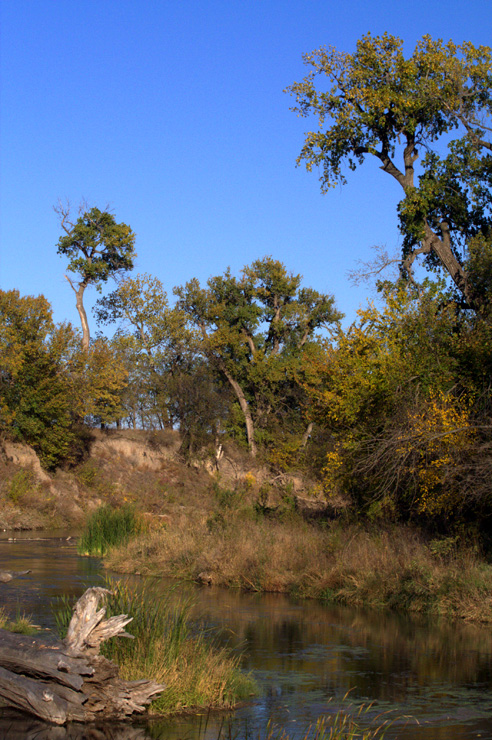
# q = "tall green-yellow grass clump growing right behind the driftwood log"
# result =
<box><xmin>55</xmin><ymin>582</ymin><xmax>256</xmax><ymax>714</ymax></box>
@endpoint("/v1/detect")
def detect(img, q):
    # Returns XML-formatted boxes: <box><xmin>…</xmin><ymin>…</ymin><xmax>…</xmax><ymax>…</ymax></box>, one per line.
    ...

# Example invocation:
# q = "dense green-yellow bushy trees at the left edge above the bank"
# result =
<box><xmin>0</xmin><ymin>290</ymin><xmax>127</xmax><ymax>469</ymax></box>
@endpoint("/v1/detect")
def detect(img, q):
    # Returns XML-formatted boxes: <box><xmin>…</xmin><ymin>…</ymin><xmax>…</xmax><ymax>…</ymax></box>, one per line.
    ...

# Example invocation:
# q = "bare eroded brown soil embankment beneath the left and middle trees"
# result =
<box><xmin>0</xmin><ymin>429</ymin><xmax>324</xmax><ymax>530</ymax></box>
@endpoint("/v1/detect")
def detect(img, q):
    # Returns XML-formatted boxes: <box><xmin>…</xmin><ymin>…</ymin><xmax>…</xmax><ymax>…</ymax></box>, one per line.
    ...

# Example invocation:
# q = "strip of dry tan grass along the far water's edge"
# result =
<box><xmin>105</xmin><ymin>503</ymin><xmax>492</xmax><ymax>623</ymax></box>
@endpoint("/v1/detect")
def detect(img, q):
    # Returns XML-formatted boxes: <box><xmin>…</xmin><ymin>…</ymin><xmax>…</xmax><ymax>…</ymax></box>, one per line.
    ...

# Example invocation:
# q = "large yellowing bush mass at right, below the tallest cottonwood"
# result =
<box><xmin>301</xmin><ymin>270</ymin><xmax>492</xmax><ymax>533</ymax></box>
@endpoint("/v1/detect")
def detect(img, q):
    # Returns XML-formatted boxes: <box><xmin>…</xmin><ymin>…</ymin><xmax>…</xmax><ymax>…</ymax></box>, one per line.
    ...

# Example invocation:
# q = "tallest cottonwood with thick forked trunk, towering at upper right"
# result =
<box><xmin>287</xmin><ymin>34</ymin><xmax>492</xmax><ymax>309</ymax></box>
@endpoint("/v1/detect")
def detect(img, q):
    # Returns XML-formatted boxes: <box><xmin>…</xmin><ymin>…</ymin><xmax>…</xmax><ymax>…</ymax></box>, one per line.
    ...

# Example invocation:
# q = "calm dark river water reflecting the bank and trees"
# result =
<box><xmin>0</xmin><ymin>533</ymin><xmax>492</xmax><ymax>740</ymax></box>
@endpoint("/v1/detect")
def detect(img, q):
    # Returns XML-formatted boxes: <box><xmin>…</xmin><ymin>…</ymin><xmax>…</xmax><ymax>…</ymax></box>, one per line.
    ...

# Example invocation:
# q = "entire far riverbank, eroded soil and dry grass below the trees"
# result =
<box><xmin>0</xmin><ymin>430</ymin><xmax>492</xmax><ymax>623</ymax></box>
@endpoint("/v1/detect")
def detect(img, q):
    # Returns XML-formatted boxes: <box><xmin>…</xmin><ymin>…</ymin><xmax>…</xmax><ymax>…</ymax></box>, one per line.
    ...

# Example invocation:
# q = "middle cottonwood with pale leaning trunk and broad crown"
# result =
<box><xmin>174</xmin><ymin>257</ymin><xmax>341</xmax><ymax>456</ymax></box>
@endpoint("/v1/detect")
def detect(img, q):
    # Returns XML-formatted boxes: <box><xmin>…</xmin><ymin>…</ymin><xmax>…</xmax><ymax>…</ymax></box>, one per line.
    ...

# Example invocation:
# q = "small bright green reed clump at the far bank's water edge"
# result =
<box><xmin>77</xmin><ymin>505</ymin><xmax>144</xmax><ymax>557</ymax></box>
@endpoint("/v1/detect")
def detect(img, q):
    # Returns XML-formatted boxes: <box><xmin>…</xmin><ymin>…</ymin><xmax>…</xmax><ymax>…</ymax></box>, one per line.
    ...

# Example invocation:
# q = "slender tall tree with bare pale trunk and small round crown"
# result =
<box><xmin>55</xmin><ymin>204</ymin><xmax>136</xmax><ymax>351</ymax></box>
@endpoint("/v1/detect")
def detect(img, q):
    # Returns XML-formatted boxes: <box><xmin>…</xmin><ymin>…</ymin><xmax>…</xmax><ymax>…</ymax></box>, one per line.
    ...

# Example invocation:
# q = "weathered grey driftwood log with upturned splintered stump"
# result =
<box><xmin>0</xmin><ymin>588</ymin><xmax>164</xmax><ymax>725</ymax></box>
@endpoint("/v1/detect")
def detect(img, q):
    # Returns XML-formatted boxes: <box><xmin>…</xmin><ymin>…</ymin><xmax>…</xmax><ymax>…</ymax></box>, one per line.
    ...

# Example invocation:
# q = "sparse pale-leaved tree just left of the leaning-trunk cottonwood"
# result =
<box><xmin>95</xmin><ymin>275</ymin><xmax>209</xmax><ymax>430</ymax></box>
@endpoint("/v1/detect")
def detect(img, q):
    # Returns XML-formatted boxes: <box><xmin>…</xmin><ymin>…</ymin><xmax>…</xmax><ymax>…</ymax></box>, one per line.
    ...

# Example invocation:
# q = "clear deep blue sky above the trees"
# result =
<box><xmin>0</xmin><ymin>0</ymin><xmax>492</xmax><ymax>328</ymax></box>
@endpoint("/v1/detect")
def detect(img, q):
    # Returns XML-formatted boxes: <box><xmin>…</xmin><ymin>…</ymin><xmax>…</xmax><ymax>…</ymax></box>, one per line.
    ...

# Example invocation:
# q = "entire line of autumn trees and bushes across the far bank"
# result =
<box><xmin>0</xmin><ymin>34</ymin><xmax>492</xmax><ymax>526</ymax></box>
